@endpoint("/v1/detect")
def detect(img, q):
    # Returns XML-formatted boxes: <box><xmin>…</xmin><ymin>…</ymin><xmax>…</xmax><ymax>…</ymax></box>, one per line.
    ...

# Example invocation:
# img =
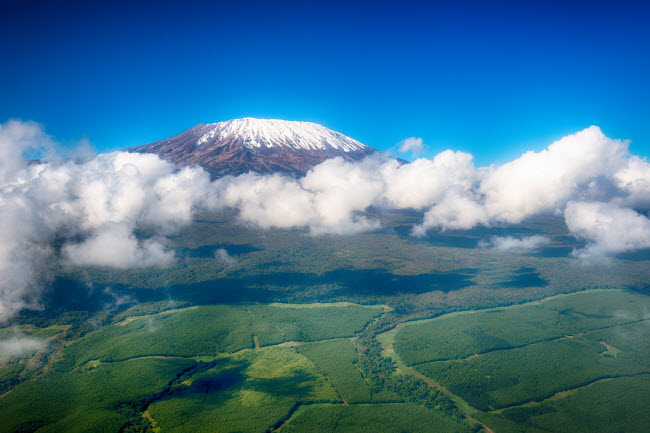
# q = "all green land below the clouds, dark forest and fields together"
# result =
<box><xmin>0</xmin><ymin>213</ymin><xmax>650</xmax><ymax>433</ymax></box>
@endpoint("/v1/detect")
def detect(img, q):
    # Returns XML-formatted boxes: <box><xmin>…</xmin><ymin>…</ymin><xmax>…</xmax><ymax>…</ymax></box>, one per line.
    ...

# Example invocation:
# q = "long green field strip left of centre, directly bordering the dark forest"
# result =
<box><xmin>58</xmin><ymin>305</ymin><xmax>383</xmax><ymax>367</ymax></box>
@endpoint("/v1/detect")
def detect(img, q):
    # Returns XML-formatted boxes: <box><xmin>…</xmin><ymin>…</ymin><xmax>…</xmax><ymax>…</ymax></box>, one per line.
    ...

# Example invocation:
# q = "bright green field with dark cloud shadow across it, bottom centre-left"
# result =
<box><xmin>148</xmin><ymin>347</ymin><xmax>340</xmax><ymax>432</ymax></box>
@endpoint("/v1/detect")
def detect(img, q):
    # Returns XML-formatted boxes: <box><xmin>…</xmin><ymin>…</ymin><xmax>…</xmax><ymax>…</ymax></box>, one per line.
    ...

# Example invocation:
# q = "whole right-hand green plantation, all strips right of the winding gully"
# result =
<box><xmin>384</xmin><ymin>290</ymin><xmax>650</xmax><ymax>432</ymax></box>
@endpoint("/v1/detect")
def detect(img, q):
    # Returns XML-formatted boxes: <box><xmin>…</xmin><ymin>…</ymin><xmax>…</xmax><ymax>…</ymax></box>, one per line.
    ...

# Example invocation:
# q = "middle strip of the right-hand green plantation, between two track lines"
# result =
<box><xmin>415</xmin><ymin>322</ymin><xmax>650</xmax><ymax>410</ymax></box>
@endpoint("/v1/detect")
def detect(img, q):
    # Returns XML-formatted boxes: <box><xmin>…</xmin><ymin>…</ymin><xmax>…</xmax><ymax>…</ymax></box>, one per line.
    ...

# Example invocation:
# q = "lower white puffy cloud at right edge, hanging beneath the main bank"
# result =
<box><xmin>564</xmin><ymin>202</ymin><xmax>650</xmax><ymax>258</ymax></box>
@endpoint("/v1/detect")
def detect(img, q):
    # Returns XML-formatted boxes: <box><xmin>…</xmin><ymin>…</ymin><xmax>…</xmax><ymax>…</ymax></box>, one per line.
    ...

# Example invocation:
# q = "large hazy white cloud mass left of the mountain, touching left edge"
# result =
<box><xmin>0</xmin><ymin>121</ymin><xmax>218</xmax><ymax>321</ymax></box>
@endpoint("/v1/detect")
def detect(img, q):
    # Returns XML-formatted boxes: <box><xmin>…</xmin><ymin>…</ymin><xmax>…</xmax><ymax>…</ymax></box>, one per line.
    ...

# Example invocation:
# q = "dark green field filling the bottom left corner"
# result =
<box><xmin>0</xmin><ymin>359</ymin><xmax>195</xmax><ymax>433</ymax></box>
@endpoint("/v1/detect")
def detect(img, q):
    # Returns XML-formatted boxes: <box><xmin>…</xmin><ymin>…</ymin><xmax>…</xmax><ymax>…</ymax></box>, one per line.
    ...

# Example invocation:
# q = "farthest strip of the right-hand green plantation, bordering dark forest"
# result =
<box><xmin>394</xmin><ymin>290</ymin><xmax>650</xmax><ymax>365</ymax></box>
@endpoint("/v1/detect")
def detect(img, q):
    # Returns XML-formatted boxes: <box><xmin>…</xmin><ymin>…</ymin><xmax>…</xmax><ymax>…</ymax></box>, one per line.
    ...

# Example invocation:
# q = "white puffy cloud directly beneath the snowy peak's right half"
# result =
<box><xmin>215</xmin><ymin>158</ymin><xmax>384</xmax><ymax>234</ymax></box>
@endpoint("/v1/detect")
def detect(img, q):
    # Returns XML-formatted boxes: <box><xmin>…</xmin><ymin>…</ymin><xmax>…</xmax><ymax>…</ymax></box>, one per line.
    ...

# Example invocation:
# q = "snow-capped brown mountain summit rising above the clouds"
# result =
<box><xmin>129</xmin><ymin>117</ymin><xmax>377</xmax><ymax>176</ymax></box>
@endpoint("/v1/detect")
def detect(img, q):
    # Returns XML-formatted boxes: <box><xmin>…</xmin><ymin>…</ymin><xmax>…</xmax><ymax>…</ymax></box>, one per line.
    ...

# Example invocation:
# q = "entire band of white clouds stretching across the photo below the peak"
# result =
<box><xmin>0</xmin><ymin>121</ymin><xmax>650</xmax><ymax>321</ymax></box>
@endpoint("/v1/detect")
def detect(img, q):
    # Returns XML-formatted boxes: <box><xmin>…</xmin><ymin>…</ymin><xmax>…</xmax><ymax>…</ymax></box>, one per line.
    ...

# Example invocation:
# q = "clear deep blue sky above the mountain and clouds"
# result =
<box><xmin>0</xmin><ymin>0</ymin><xmax>650</xmax><ymax>163</ymax></box>
